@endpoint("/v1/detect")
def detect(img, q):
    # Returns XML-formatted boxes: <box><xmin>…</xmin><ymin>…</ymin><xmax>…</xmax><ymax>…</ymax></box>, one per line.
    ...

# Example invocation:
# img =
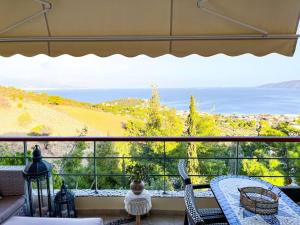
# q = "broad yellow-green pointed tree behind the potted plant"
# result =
<box><xmin>126</xmin><ymin>86</ymin><xmax>186</xmax><ymax>188</ymax></box>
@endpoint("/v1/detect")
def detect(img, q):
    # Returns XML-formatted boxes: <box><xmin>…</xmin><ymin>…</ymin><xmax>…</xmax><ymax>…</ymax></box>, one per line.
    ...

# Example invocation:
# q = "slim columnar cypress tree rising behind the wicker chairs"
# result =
<box><xmin>186</xmin><ymin>96</ymin><xmax>203</xmax><ymax>184</ymax></box>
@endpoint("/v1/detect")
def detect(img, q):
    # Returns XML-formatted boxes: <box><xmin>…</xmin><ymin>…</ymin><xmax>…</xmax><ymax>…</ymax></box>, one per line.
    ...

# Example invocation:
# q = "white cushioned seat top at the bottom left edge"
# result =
<box><xmin>3</xmin><ymin>216</ymin><xmax>103</xmax><ymax>225</ymax></box>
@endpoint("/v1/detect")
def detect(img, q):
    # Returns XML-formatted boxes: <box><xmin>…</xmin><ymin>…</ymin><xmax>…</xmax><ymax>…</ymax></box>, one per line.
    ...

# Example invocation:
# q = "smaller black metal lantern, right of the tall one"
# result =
<box><xmin>54</xmin><ymin>181</ymin><xmax>76</xmax><ymax>217</ymax></box>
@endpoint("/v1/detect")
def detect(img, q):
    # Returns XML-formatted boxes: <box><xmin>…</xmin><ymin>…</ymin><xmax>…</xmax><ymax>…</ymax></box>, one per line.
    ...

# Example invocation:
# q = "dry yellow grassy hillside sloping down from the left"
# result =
<box><xmin>0</xmin><ymin>87</ymin><xmax>129</xmax><ymax>136</ymax></box>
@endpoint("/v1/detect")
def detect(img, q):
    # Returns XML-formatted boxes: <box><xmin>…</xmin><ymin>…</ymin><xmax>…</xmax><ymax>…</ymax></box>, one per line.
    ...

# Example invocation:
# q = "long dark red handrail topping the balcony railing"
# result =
<box><xmin>0</xmin><ymin>136</ymin><xmax>300</xmax><ymax>142</ymax></box>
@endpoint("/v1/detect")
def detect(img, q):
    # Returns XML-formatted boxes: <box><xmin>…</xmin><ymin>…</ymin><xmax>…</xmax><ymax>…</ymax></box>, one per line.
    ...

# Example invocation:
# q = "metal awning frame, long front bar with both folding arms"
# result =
<box><xmin>0</xmin><ymin>0</ymin><xmax>300</xmax><ymax>42</ymax></box>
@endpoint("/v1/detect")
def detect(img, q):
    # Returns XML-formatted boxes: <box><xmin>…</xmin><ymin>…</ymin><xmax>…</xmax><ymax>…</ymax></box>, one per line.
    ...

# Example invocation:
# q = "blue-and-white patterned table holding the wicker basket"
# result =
<box><xmin>211</xmin><ymin>176</ymin><xmax>300</xmax><ymax>225</ymax></box>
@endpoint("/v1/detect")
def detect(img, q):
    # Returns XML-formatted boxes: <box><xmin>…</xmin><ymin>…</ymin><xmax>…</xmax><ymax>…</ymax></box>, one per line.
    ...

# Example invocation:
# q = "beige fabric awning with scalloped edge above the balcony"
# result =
<box><xmin>0</xmin><ymin>0</ymin><xmax>300</xmax><ymax>57</ymax></box>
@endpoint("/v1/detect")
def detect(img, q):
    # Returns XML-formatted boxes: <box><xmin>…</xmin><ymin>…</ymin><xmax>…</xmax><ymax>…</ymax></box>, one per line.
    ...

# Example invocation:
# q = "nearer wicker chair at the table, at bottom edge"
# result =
<box><xmin>184</xmin><ymin>184</ymin><xmax>228</xmax><ymax>225</ymax></box>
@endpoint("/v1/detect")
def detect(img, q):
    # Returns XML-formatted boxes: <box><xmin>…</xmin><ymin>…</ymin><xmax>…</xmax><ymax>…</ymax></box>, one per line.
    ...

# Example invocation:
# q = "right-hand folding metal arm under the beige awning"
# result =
<box><xmin>197</xmin><ymin>0</ymin><xmax>268</xmax><ymax>36</ymax></box>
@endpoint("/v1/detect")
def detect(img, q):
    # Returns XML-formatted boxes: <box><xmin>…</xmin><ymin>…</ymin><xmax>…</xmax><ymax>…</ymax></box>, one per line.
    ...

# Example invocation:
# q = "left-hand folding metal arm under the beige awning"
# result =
<box><xmin>0</xmin><ymin>0</ymin><xmax>52</xmax><ymax>34</ymax></box>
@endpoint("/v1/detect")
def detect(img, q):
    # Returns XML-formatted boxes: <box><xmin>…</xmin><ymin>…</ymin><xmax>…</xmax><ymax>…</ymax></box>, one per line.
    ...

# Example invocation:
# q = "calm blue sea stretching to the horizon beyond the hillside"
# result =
<box><xmin>35</xmin><ymin>88</ymin><xmax>300</xmax><ymax>115</ymax></box>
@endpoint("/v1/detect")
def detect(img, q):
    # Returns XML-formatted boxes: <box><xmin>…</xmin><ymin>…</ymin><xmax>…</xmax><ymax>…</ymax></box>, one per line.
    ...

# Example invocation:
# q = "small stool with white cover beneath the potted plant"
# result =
<box><xmin>124</xmin><ymin>190</ymin><xmax>152</xmax><ymax>225</ymax></box>
